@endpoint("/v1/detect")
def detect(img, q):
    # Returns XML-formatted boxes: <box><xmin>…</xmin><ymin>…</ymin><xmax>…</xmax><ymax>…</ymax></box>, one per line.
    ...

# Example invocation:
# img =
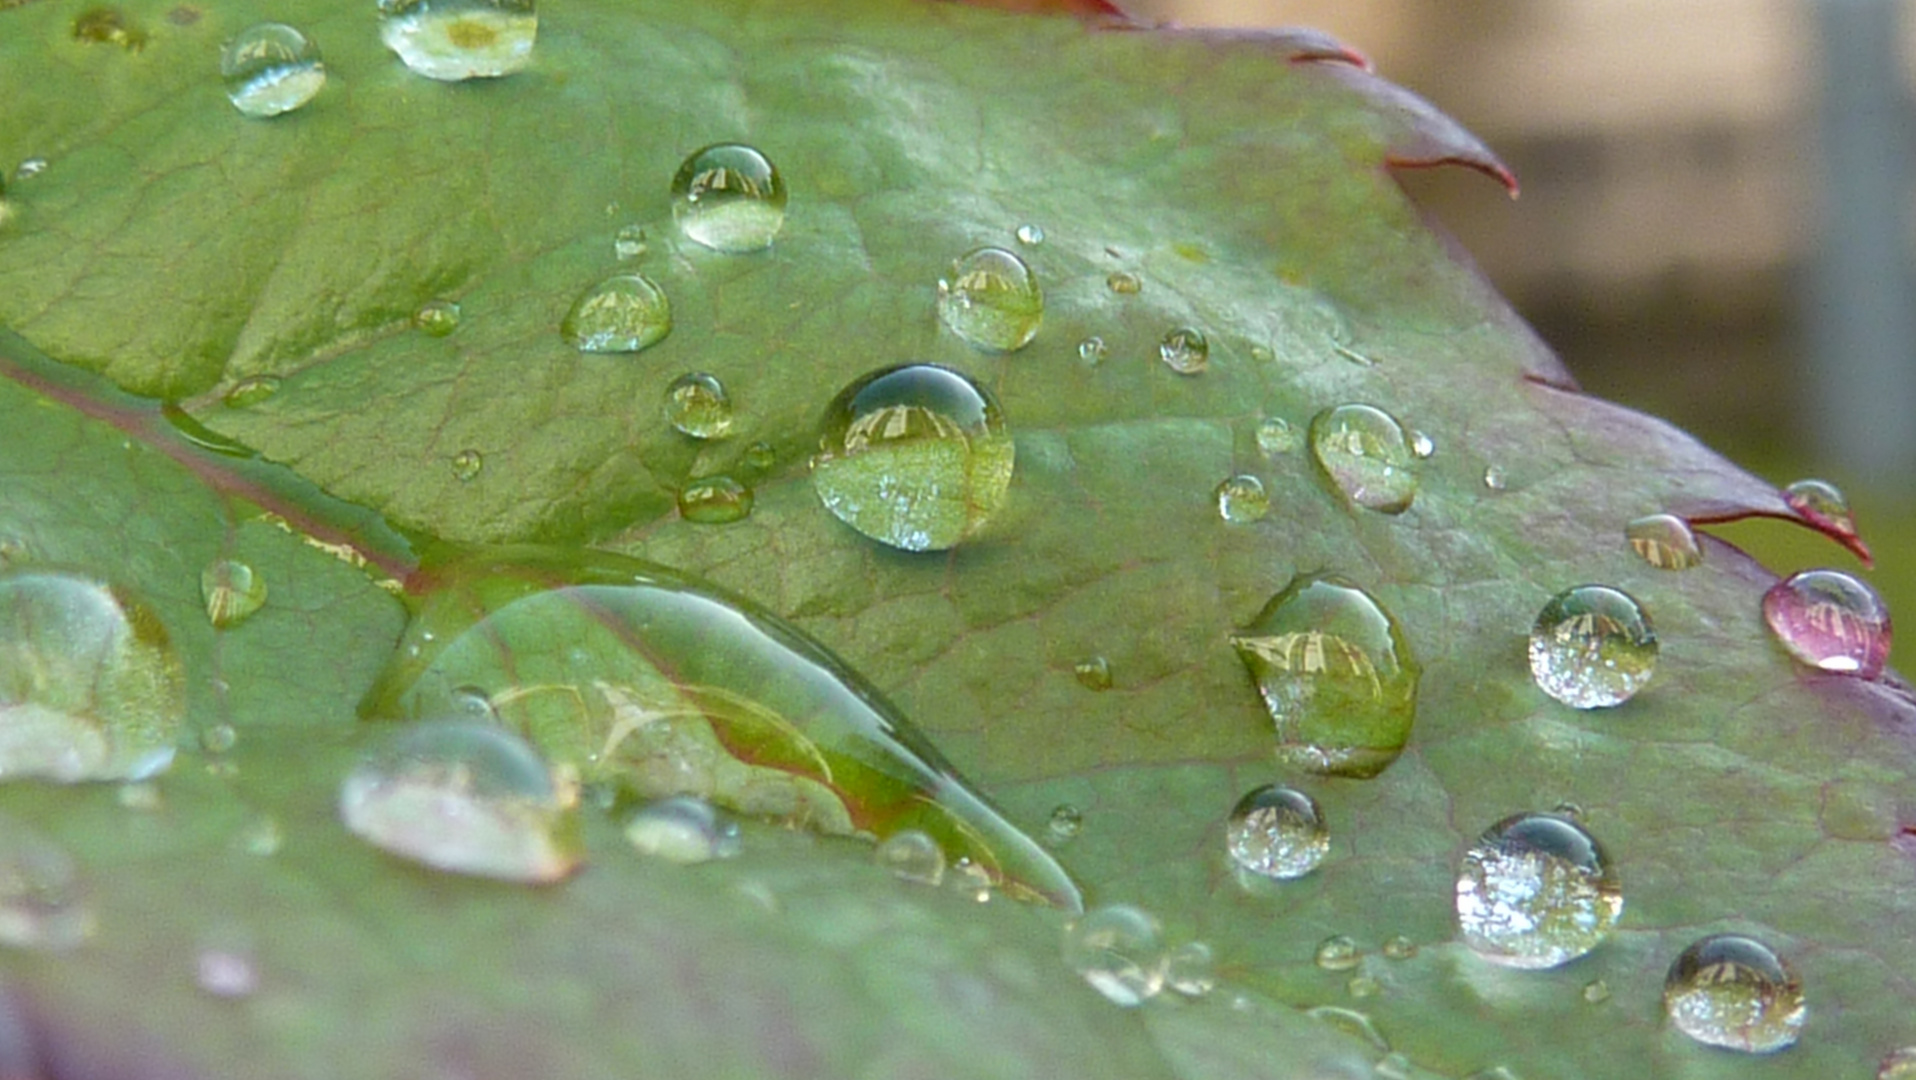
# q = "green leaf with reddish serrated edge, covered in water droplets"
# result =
<box><xmin>0</xmin><ymin>0</ymin><xmax>1916</xmax><ymax>1078</ymax></box>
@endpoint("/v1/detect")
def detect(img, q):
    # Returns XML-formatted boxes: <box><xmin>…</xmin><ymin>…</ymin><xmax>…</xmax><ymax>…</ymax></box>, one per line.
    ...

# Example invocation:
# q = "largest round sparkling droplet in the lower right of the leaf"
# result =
<box><xmin>1456</xmin><ymin>814</ymin><xmax>1623</xmax><ymax>969</ymax></box>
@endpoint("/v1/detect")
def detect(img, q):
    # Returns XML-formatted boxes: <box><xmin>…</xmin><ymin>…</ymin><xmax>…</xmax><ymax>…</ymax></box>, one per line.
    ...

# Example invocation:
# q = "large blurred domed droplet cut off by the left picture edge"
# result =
<box><xmin>0</xmin><ymin>569</ymin><xmax>186</xmax><ymax>783</ymax></box>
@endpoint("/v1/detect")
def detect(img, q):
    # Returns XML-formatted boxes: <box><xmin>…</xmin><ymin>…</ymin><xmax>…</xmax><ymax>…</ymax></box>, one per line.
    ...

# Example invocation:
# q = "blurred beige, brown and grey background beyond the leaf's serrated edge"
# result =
<box><xmin>1127</xmin><ymin>0</ymin><xmax>1916</xmax><ymax>674</ymax></box>
